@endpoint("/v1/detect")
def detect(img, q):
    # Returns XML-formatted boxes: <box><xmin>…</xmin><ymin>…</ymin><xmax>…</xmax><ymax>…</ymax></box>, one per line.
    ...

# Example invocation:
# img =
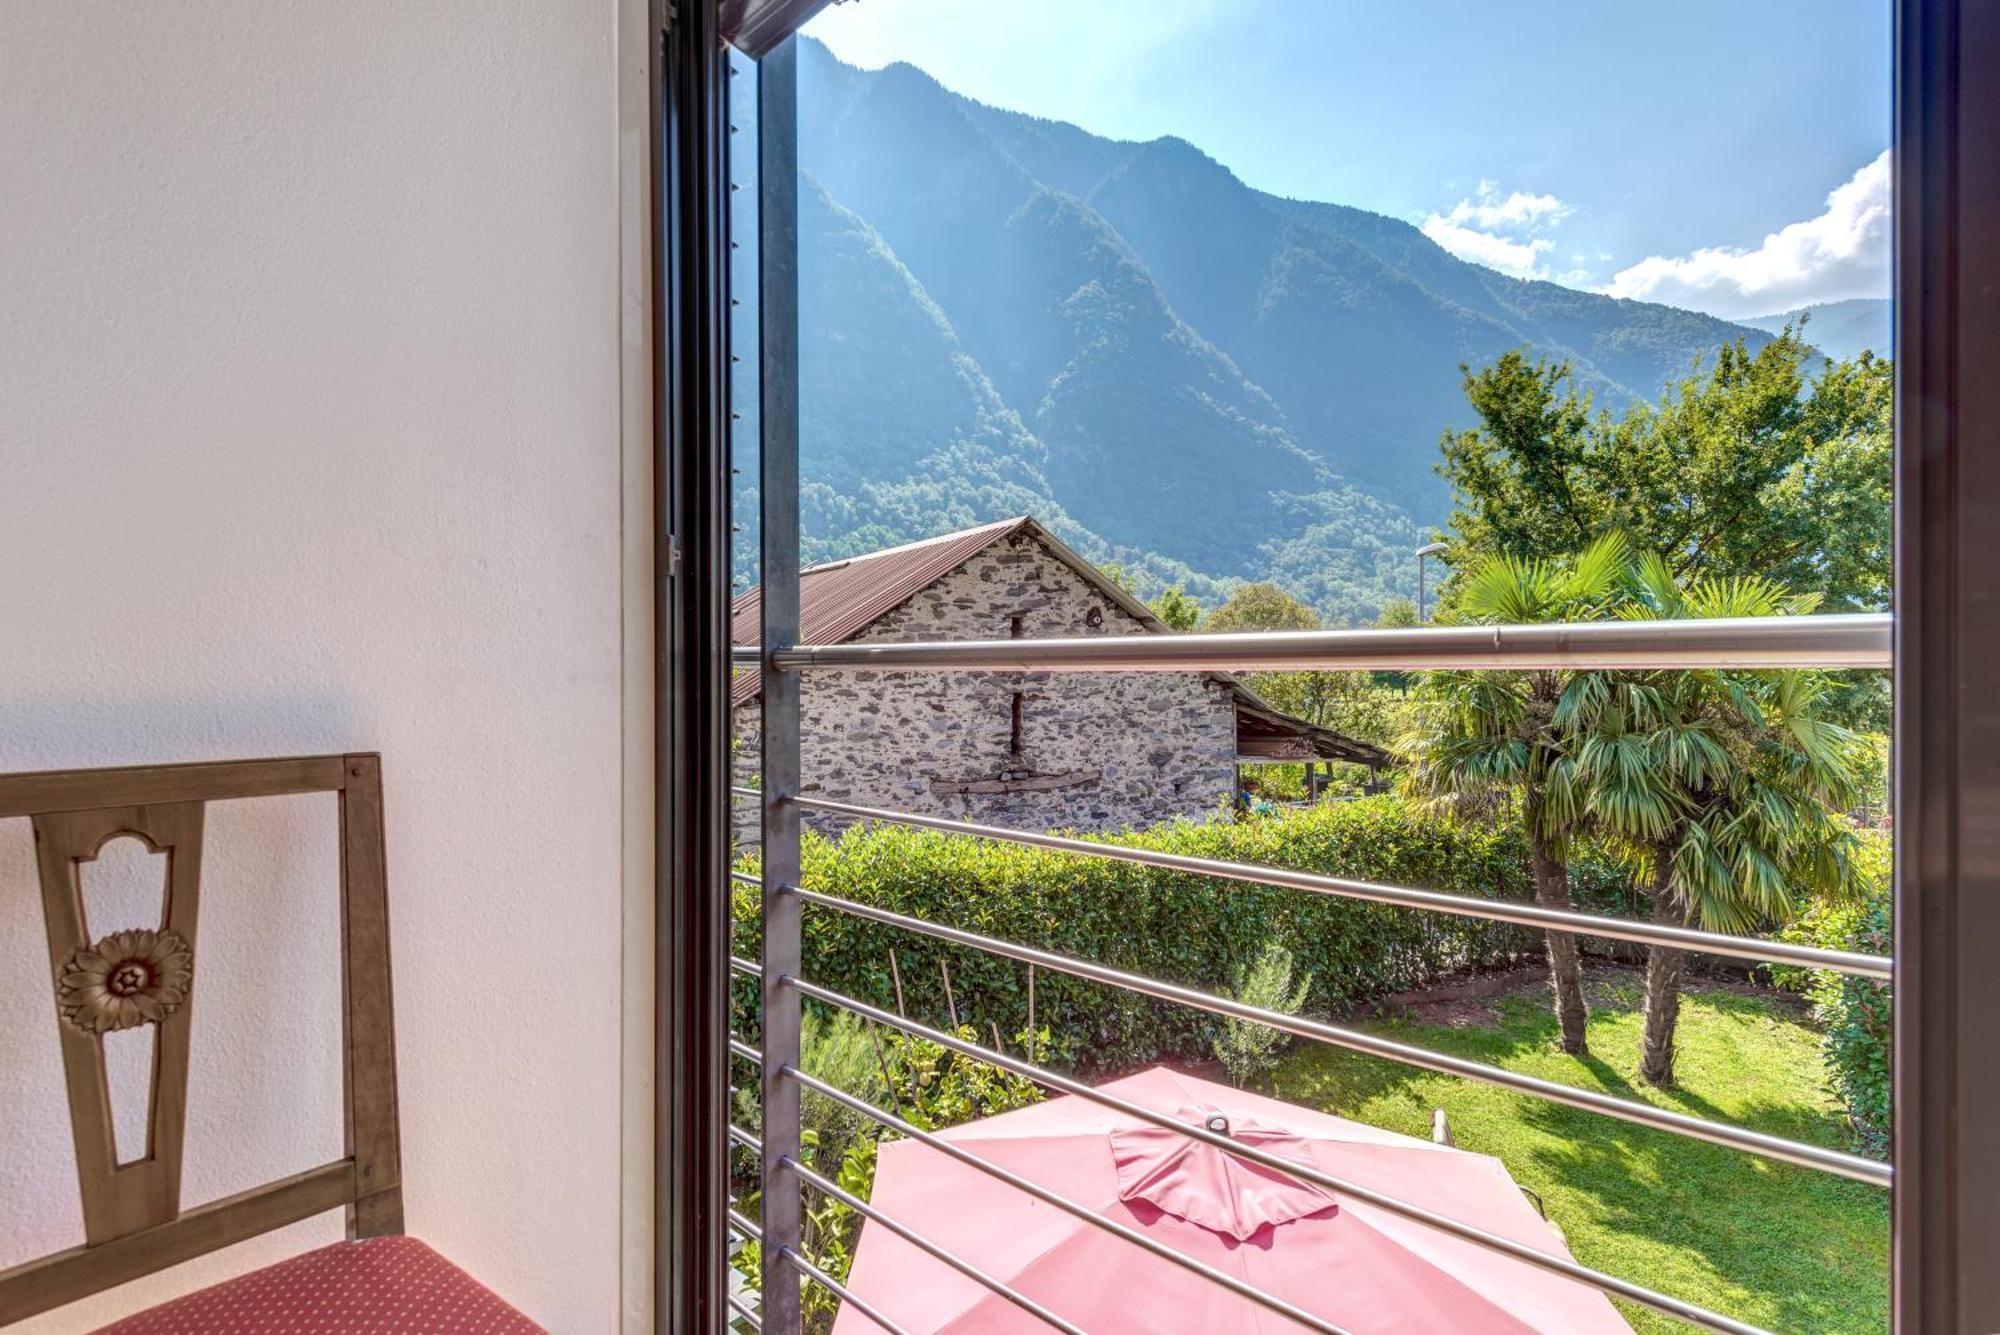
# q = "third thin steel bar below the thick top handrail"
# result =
<box><xmin>784</xmin><ymin>977</ymin><xmax>1770</xmax><ymax>1335</ymax></box>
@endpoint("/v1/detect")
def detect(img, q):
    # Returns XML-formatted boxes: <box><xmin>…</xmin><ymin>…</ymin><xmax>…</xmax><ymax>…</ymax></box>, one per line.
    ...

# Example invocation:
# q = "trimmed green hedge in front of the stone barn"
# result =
<box><xmin>734</xmin><ymin>797</ymin><xmax>1538</xmax><ymax>1071</ymax></box>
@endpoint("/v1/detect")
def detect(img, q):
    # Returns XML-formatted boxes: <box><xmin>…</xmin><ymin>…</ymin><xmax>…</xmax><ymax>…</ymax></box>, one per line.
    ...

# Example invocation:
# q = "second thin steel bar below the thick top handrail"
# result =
<box><xmin>792</xmin><ymin>887</ymin><xmax>1894</xmax><ymax>1187</ymax></box>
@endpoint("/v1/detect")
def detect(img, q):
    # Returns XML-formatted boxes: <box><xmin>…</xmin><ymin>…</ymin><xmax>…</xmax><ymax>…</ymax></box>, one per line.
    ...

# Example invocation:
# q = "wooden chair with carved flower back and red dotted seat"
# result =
<box><xmin>0</xmin><ymin>753</ymin><xmax>540</xmax><ymax>1335</ymax></box>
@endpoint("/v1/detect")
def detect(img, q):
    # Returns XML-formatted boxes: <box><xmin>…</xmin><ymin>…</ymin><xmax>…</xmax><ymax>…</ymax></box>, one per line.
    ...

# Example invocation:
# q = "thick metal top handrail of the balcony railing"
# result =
<box><xmin>740</xmin><ymin>612</ymin><xmax>1892</xmax><ymax>671</ymax></box>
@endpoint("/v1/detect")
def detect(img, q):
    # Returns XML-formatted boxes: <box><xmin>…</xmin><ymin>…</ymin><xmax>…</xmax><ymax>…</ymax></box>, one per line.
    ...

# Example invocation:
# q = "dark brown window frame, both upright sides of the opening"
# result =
<box><xmin>654</xmin><ymin>0</ymin><xmax>2000</xmax><ymax>1335</ymax></box>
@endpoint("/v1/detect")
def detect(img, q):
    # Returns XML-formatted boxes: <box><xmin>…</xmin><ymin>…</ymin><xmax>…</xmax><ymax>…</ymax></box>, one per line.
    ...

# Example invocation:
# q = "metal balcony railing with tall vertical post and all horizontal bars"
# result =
<box><xmin>728</xmin><ymin>42</ymin><xmax>1892</xmax><ymax>1335</ymax></box>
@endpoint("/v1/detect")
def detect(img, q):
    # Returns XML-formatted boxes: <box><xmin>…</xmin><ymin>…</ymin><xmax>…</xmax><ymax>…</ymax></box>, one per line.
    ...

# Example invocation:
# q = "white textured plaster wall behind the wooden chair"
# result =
<box><xmin>0</xmin><ymin>0</ymin><xmax>622</xmax><ymax>1335</ymax></box>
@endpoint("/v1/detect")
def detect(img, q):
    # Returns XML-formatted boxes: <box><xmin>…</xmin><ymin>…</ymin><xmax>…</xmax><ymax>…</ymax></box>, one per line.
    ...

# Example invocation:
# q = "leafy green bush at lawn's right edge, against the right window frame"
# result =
<box><xmin>1772</xmin><ymin>829</ymin><xmax>1894</xmax><ymax>1151</ymax></box>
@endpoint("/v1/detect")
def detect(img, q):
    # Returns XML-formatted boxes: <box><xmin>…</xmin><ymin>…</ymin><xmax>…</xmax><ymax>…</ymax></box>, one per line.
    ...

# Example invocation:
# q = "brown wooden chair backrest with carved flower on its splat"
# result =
<box><xmin>0</xmin><ymin>753</ymin><xmax>402</xmax><ymax>1325</ymax></box>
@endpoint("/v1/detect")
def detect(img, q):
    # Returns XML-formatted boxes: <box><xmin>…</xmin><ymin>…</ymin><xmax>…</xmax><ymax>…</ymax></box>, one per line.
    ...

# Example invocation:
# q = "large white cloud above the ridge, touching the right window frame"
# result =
<box><xmin>1604</xmin><ymin>150</ymin><xmax>1892</xmax><ymax>318</ymax></box>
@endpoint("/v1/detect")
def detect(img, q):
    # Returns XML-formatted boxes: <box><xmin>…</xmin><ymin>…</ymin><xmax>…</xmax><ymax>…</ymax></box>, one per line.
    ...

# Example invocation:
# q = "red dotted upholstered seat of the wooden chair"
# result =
<box><xmin>98</xmin><ymin>1237</ymin><xmax>546</xmax><ymax>1335</ymax></box>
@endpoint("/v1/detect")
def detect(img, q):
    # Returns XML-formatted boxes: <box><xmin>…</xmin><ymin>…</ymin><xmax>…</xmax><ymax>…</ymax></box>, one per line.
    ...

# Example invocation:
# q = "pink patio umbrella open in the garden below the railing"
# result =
<box><xmin>834</xmin><ymin>1067</ymin><xmax>1632</xmax><ymax>1335</ymax></box>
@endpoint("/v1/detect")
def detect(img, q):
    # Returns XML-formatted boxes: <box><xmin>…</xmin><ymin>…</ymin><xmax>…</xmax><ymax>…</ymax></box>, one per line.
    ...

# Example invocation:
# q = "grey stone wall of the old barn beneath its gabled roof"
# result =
<box><xmin>734</xmin><ymin>534</ymin><xmax>1236</xmax><ymax>843</ymax></box>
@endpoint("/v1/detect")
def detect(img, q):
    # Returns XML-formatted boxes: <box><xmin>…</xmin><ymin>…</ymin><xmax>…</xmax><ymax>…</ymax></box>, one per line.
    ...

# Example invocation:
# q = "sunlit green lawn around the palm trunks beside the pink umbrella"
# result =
<box><xmin>1272</xmin><ymin>971</ymin><xmax>1888</xmax><ymax>1333</ymax></box>
